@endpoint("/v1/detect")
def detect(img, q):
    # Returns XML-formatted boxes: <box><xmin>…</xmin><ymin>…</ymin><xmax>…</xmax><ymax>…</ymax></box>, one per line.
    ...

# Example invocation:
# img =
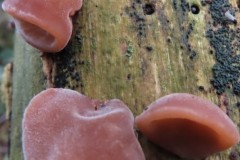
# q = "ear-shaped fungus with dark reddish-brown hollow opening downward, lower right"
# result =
<box><xmin>136</xmin><ymin>93</ymin><xmax>239</xmax><ymax>159</ymax></box>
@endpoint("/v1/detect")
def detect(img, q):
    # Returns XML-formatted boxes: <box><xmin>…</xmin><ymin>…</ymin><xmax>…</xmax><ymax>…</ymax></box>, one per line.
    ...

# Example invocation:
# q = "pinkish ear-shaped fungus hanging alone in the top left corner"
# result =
<box><xmin>2</xmin><ymin>0</ymin><xmax>82</xmax><ymax>52</ymax></box>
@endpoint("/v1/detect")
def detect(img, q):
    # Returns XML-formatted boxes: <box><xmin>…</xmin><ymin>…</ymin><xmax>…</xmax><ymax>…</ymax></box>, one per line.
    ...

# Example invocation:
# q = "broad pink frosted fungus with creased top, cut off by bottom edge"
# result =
<box><xmin>23</xmin><ymin>89</ymin><xmax>145</xmax><ymax>160</ymax></box>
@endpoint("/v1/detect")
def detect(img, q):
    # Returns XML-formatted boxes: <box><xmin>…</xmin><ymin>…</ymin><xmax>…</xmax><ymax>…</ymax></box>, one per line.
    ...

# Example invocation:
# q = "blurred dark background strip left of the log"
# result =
<box><xmin>0</xmin><ymin>0</ymin><xmax>14</xmax><ymax>160</ymax></box>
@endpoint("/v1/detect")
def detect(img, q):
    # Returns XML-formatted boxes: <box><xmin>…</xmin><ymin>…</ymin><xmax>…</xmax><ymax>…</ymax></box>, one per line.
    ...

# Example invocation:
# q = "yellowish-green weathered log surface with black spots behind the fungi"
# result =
<box><xmin>8</xmin><ymin>0</ymin><xmax>240</xmax><ymax>160</ymax></box>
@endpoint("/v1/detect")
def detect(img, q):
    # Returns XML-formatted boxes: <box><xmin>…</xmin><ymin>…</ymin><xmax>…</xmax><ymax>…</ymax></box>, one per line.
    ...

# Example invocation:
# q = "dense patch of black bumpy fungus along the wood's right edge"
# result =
<box><xmin>206</xmin><ymin>0</ymin><xmax>240</xmax><ymax>95</ymax></box>
